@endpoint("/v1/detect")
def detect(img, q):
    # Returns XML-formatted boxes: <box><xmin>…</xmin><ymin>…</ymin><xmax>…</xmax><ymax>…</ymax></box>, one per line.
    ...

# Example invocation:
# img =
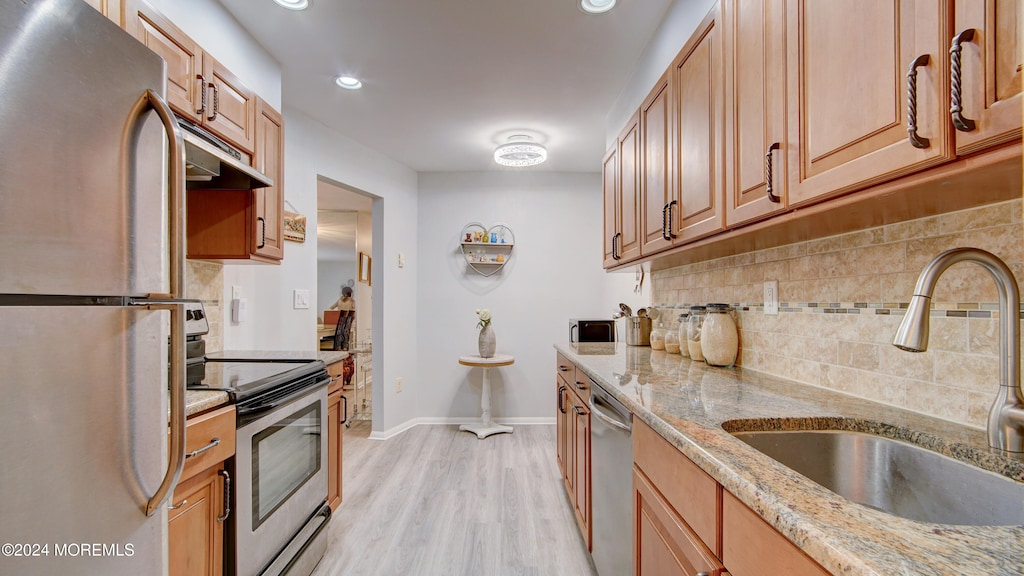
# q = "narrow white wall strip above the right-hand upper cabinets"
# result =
<box><xmin>605</xmin><ymin>0</ymin><xmax>716</xmax><ymax>148</ymax></box>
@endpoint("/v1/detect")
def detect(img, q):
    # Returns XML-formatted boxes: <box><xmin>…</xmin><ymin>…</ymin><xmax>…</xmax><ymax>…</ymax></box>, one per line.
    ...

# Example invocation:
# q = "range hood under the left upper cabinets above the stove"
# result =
<box><xmin>178</xmin><ymin>118</ymin><xmax>273</xmax><ymax>190</ymax></box>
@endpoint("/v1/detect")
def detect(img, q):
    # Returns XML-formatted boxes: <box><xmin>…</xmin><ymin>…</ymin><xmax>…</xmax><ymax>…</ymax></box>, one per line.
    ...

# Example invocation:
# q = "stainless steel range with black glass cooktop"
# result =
<box><xmin>186</xmin><ymin>304</ymin><xmax>331</xmax><ymax>576</ymax></box>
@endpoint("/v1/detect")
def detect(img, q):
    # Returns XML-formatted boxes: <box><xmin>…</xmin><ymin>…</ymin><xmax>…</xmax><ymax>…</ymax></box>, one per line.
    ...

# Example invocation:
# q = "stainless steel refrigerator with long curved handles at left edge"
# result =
<box><xmin>0</xmin><ymin>0</ymin><xmax>190</xmax><ymax>576</ymax></box>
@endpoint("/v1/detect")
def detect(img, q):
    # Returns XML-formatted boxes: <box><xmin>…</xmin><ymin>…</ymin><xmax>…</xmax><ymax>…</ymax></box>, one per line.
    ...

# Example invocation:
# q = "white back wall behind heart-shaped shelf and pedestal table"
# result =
<box><xmin>417</xmin><ymin>171</ymin><xmax>634</xmax><ymax>421</ymax></box>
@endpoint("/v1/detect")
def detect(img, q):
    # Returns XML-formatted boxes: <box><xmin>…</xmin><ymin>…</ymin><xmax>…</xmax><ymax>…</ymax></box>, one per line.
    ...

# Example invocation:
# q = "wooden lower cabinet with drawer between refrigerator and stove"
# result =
<box><xmin>167</xmin><ymin>406</ymin><xmax>234</xmax><ymax>576</ymax></box>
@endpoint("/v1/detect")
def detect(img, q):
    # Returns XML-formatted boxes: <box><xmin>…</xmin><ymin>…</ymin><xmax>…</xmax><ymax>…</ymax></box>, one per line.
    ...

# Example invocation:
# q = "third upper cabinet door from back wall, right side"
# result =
<box><xmin>640</xmin><ymin>73</ymin><xmax>679</xmax><ymax>256</ymax></box>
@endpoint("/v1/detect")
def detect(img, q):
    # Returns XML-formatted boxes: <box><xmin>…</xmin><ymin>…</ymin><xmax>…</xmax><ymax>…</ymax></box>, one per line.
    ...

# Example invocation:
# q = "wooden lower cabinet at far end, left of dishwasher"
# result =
<box><xmin>555</xmin><ymin>355</ymin><xmax>592</xmax><ymax>549</ymax></box>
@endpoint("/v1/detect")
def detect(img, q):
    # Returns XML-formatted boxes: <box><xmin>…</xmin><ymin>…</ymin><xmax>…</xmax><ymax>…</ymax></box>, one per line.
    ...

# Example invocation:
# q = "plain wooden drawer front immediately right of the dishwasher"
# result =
<box><xmin>633</xmin><ymin>419</ymin><xmax>720</xmax><ymax>553</ymax></box>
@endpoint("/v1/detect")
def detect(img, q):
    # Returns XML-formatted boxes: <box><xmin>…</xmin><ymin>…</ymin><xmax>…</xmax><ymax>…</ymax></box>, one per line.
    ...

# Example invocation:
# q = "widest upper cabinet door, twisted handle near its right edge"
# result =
<box><xmin>785</xmin><ymin>0</ymin><xmax>952</xmax><ymax>206</ymax></box>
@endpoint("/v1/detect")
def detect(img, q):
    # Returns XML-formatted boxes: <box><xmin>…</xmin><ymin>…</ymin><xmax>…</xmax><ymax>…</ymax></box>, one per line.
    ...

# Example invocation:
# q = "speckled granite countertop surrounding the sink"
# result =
<box><xmin>555</xmin><ymin>343</ymin><xmax>1024</xmax><ymax>576</ymax></box>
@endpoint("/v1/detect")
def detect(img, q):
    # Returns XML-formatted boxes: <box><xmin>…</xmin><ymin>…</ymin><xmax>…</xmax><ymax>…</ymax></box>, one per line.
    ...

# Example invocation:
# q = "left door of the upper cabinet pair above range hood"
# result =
<box><xmin>135</xmin><ymin>1</ymin><xmax>204</xmax><ymax>123</ymax></box>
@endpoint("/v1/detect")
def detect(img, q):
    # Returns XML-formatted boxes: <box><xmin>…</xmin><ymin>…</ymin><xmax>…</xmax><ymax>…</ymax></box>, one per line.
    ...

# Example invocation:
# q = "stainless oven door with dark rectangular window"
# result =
<box><xmin>232</xmin><ymin>385</ymin><xmax>328</xmax><ymax>576</ymax></box>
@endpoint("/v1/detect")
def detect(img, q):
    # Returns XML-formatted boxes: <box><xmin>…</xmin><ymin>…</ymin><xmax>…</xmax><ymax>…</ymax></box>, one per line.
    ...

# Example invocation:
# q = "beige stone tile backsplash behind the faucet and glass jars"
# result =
<box><xmin>651</xmin><ymin>200</ymin><xmax>1024</xmax><ymax>427</ymax></box>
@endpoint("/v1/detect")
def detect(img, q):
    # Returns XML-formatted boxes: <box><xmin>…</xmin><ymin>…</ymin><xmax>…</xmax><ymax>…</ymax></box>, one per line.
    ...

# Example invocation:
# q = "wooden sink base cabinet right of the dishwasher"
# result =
<box><xmin>633</xmin><ymin>419</ymin><xmax>829</xmax><ymax>576</ymax></box>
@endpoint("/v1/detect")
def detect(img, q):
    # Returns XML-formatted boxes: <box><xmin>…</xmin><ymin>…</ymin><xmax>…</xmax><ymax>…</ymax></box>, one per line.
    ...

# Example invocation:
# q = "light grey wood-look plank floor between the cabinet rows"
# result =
<box><xmin>313</xmin><ymin>421</ymin><xmax>596</xmax><ymax>576</ymax></box>
